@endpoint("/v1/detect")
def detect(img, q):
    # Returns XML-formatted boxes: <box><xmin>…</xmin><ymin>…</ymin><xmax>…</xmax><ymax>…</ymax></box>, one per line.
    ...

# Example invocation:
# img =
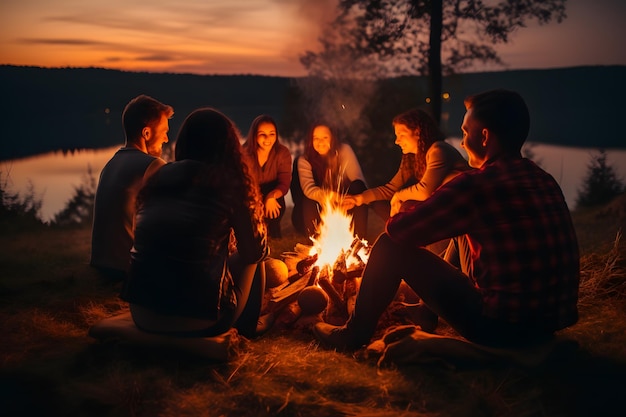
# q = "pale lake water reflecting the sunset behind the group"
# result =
<box><xmin>0</xmin><ymin>139</ymin><xmax>626</xmax><ymax>221</ymax></box>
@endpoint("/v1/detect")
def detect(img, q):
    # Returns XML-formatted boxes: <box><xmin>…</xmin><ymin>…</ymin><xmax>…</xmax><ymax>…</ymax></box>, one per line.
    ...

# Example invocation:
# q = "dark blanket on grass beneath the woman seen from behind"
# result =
<box><xmin>88</xmin><ymin>312</ymin><xmax>245</xmax><ymax>362</ymax></box>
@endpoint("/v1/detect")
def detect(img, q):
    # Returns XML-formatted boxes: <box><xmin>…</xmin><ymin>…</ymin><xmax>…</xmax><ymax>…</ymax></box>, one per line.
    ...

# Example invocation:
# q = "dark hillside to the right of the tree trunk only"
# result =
<box><xmin>444</xmin><ymin>66</ymin><xmax>626</xmax><ymax>148</ymax></box>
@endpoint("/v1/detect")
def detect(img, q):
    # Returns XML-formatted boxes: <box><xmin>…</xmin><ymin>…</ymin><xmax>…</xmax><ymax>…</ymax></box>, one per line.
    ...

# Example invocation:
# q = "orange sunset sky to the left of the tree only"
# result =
<box><xmin>0</xmin><ymin>0</ymin><xmax>335</xmax><ymax>76</ymax></box>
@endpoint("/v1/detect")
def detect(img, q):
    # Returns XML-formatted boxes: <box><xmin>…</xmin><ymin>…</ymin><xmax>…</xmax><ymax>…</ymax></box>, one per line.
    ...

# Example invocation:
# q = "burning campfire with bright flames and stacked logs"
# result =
<box><xmin>270</xmin><ymin>199</ymin><xmax>370</xmax><ymax>322</ymax></box>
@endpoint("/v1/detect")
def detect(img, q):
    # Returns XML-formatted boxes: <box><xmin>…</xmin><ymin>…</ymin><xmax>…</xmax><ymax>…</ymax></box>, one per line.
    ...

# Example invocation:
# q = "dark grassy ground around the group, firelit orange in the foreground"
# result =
<box><xmin>0</xmin><ymin>199</ymin><xmax>626</xmax><ymax>416</ymax></box>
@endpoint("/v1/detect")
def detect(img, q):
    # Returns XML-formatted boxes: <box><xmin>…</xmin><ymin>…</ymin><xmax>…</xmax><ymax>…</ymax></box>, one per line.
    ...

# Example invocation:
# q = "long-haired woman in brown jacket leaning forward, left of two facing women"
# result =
<box><xmin>243</xmin><ymin>114</ymin><xmax>291</xmax><ymax>238</ymax></box>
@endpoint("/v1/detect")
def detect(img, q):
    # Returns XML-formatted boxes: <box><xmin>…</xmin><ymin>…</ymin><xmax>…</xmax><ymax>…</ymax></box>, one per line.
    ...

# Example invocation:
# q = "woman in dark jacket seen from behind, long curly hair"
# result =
<box><xmin>123</xmin><ymin>108</ymin><xmax>268</xmax><ymax>337</ymax></box>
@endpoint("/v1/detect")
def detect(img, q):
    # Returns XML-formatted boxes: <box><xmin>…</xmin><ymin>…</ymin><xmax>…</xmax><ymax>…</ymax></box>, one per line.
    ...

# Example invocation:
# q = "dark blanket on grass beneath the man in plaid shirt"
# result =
<box><xmin>366</xmin><ymin>325</ymin><xmax>578</xmax><ymax>368</ymax></box>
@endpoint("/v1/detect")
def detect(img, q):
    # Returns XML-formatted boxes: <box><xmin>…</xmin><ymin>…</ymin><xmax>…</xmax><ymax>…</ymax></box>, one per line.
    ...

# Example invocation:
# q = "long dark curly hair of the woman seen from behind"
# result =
<box><xmin>174</xmin><ymin>107</ymin><xmax>265</xmax><ymax>236</ymax></box>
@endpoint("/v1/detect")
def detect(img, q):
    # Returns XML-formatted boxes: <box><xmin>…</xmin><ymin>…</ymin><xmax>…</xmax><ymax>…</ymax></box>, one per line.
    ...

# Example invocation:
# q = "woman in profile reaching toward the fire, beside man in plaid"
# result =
<box><xmin>345</xmin><ymin>109</ymin><xmax>470</xmax><ymax>219</ymax></box>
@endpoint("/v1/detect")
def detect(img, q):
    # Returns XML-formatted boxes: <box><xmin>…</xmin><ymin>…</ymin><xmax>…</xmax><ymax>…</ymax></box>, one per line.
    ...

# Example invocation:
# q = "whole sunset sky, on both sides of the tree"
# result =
<box><xmin>0</xmin><ymin>0</ymin><xmax>626</xmax><ymax>76</ymax></box>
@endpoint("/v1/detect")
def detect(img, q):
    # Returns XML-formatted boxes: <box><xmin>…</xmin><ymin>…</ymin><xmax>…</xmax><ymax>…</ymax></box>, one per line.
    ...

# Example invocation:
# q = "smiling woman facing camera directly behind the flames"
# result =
<box><xmin>291</xmin><ymin>122</ymin><xmax>367</xmax><ymax>238</ymax></box>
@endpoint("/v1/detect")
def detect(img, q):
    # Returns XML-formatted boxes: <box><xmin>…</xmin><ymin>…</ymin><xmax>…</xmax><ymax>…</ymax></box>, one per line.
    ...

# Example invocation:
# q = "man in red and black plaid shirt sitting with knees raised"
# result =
<box><xmin>314</xmin><ymin>90</ymin><xmax>580</xmax><ymax>350</ymax></box>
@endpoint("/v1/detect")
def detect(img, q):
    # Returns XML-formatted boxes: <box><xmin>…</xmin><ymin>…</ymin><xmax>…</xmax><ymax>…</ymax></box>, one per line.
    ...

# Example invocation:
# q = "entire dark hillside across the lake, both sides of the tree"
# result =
<box><xmin>0</xmin><ymin>65</ymin><xmax>626</xmax><ymax>161</ymax></box>
